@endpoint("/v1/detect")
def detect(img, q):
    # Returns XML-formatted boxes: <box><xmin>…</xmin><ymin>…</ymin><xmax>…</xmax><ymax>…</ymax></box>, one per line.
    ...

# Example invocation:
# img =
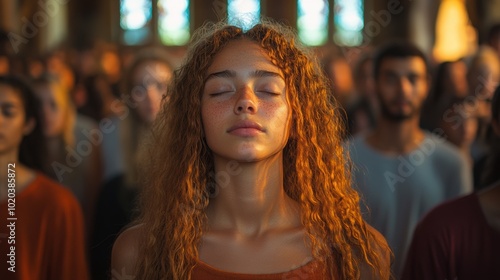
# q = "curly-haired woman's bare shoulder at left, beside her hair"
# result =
<box><xmin>111</xmin><ymin>224</ymin><xmax>143</xmax><ymax>279</ymax></box>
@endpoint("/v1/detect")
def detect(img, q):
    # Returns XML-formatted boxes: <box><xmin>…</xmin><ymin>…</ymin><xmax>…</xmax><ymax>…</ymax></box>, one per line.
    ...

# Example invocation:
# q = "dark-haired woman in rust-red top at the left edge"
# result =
<box><xmin>0</xmin><ymin>76</ymin><xmax>88</xmax><ymax>280</ymax></box>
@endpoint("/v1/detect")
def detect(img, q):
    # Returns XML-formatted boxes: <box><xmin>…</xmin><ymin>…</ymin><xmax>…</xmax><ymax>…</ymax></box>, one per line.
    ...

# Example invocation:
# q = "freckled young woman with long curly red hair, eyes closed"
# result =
<box><xmin>112</xmin><ymin>22</ymin><xmax>390</xmax><ymax>280</ymax></box>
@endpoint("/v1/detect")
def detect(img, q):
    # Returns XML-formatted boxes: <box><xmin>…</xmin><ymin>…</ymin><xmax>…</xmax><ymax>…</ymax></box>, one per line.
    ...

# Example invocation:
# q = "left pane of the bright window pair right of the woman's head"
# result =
<box><xmin>297</xmin><ymin>0</ymin><xmax>329</xmax><ymax>46</ymax></box>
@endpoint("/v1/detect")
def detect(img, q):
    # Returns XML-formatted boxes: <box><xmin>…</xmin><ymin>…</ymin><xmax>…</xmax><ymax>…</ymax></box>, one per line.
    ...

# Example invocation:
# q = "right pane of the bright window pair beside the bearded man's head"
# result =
<box><xmin>333</xmin><ymin>0</ymin><xmax>364</xmax><ymax>46</ymax></box>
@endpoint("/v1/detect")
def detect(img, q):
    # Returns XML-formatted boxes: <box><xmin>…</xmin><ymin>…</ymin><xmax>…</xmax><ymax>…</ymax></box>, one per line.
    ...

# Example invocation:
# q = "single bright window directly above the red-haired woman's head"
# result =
<box><xmin>227</xmin><ymin>0</ymin><xmax>260</xmax><ymax>30</ymax></box>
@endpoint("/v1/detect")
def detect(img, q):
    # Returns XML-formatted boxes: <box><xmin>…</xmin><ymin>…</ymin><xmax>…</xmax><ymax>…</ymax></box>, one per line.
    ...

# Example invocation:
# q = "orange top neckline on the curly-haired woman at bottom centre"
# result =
<box><xmin>191</xmin><ymin>261</ymin><xmax>330</xmax><ymax>280</ymax></box>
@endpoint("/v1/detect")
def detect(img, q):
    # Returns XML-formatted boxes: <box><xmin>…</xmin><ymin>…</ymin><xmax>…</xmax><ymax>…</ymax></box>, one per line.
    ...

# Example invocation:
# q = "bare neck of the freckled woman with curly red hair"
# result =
<box><xmin>207</xmin><ymin>153</ymin><xmax>300</xmax><ymax>236</ymax></box>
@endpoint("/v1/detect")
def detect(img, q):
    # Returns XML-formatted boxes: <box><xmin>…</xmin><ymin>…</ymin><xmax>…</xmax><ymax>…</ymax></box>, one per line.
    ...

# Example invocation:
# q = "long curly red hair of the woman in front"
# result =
<box><xmin>136</xmin><ymin>22</ymin><xmax>386</xmax><ymax>279</ymax></box>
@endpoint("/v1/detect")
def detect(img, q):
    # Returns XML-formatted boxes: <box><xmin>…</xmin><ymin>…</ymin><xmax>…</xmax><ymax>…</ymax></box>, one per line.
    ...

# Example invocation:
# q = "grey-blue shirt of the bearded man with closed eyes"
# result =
<box><xmin>348</xmin><ymin>133</ymin><xmax>472</xmax><ymax>276</ymax></box>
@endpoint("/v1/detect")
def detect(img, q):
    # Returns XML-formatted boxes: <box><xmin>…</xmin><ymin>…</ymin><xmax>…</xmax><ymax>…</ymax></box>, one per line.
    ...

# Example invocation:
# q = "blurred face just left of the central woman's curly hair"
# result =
<box><xmin>131</xmin><ymin>61</ymin><xmax>172</xmax><ymax>123</ymax></box>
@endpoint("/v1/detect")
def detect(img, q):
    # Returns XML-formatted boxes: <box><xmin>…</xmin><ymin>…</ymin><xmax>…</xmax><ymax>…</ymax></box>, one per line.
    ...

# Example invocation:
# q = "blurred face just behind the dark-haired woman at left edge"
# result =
<box><xmin>35</xmin><ymin>83</ymin><xmax>69</xmax><ymax>137</ymax></box>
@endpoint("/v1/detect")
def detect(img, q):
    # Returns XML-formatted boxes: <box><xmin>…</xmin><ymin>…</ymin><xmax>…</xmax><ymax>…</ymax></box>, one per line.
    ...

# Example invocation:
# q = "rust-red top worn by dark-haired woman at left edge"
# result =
<box><xmin>0</xmin><ymin>173</ymin><xmax>89</xmax><ymax>280</ymax></box>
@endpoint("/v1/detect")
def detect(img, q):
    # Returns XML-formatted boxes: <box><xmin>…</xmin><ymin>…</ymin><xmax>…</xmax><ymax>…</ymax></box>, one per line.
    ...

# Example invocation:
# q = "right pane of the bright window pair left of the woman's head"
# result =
<box><xmin>158</xmin><ymin>0</ymin><xmax>191</xmax><ymax>46</ymax></box>
